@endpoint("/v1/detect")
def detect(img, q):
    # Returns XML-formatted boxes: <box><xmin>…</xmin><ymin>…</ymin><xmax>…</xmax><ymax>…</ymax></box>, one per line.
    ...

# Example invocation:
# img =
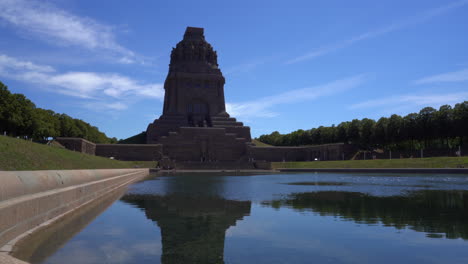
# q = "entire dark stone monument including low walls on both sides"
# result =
<box><xmin>57</xmin><ymin>27</ymin><xmax>356</xmax><ymax>169</ymax></box>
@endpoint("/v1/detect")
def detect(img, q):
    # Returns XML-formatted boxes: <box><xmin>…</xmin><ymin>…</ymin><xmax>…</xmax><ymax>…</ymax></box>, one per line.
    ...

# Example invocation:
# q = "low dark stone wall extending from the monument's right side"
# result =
<box><xmin>248</xmin><ymin>144</ymin><xmax>356</xmax><ymax>162</ymax></box>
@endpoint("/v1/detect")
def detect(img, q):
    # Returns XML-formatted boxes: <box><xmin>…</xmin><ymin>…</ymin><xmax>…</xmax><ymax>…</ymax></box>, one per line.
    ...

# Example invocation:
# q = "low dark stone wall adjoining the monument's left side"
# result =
<box><xmin>96</xmin><ymin>144</ymin><xmax>163</xmax><ymax>161</ymax></box>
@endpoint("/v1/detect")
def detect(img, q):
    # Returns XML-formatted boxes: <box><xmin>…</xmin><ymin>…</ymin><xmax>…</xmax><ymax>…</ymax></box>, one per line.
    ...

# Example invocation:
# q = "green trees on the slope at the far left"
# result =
<box><xmin>0</xmin><ymin>82</ymin><xmax>117</xmax><ymax>143</ymax></box>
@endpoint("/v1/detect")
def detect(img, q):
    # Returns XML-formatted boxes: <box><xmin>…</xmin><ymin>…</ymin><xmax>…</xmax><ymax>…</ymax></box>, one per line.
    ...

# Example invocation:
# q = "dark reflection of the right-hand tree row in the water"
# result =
<box><xmin>263</xmin><ymin>190</ymin><xmax>468</xmax><ymax>239</ymax></box>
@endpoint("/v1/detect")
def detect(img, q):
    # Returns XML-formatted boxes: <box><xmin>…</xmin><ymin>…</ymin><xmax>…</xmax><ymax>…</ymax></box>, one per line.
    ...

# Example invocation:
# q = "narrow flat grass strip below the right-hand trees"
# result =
<box><xmin>272</xmin><ymin>157</ymin><xmax>468</xmax><ymax>169</ymax></box>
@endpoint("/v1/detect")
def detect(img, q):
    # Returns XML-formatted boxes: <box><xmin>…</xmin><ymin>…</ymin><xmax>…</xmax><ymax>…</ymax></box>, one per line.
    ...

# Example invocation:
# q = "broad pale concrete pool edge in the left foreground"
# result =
<box><xmin>0</xmin><ymin>169</ymin><xmax>149</xmax><ymax>263</ymax></box>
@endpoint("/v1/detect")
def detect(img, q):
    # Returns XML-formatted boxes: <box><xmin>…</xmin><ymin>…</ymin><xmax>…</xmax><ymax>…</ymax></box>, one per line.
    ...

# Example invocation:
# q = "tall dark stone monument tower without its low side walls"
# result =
<box><xmin>146</xmin><ymin>27</ymin><xmax>251</xmax><ymax>161</ymax></box>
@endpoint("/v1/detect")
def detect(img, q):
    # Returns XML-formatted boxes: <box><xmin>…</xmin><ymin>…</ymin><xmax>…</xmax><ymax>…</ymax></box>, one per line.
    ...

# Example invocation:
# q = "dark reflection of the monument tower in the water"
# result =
<box><xmin>122</xmin><ymin>194</ymin><xmax>251</xmax><ymax>264</ymax></box>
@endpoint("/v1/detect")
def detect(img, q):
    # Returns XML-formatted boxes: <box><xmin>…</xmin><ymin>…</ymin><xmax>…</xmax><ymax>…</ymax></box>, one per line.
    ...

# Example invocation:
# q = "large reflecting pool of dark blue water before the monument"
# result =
<box><xmin>14</xmin><ymin>173</ymin><xmax>468</xmax><ymax>264</ymax></box>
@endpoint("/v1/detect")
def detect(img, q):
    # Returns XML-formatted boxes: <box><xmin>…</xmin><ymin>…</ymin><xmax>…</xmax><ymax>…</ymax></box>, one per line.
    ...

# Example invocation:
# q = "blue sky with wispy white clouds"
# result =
<box><xmin>0</xmin><ymin>0</ymin><xmax>468</xmax><ymax>139</ymax></box>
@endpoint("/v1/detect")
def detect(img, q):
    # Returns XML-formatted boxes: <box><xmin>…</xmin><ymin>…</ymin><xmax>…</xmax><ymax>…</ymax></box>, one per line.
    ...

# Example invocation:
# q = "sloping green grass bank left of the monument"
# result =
<box><xmin>0</xmin><ymin>136</ymin><xmax>156</xmax><ymax>170</ymax></box>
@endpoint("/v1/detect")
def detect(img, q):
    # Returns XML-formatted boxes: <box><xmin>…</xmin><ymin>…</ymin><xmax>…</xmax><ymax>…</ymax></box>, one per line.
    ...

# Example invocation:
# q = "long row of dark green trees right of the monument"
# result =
<box><xmin>258</xmin><ymin>101</ymin><xmax>468</xmax><ymax>150</ymax></box>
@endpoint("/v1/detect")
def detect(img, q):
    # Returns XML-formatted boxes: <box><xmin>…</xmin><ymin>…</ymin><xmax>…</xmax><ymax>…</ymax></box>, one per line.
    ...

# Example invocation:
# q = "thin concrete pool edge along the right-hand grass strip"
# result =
<box><xmin>276</xmin><ymin>168</ymin><xmax>468</xmax><ymax>174</ymax></box>
